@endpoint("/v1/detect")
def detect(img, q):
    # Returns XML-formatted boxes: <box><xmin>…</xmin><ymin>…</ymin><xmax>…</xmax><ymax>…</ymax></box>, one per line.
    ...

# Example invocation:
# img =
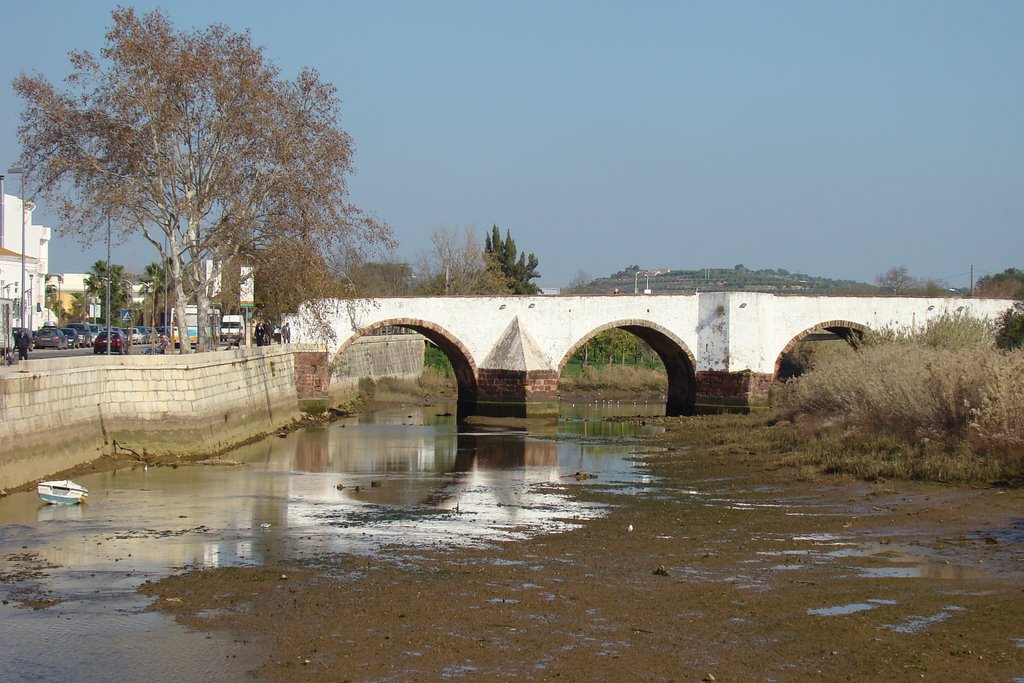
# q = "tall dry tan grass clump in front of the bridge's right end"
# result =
<box><xmin>776</xmin><ymin>316</ymin><xmax>1024</xmax><ymax>478</ymax></box>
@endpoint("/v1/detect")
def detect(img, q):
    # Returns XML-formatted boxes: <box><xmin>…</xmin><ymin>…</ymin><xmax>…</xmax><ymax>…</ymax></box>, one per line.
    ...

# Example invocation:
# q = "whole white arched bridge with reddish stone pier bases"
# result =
<box><xmin>291</xmin><ymin>292</ymin><xmax>1014</xmax><ymax>415</ymax></box>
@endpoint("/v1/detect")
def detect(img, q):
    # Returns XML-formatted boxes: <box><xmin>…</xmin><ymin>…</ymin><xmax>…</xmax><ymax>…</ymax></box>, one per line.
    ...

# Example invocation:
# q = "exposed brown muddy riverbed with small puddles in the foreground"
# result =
<box><xmin>142</xmin><ymin>413</ymin><xmax>1024</xmax><ymax>681</ymax></box>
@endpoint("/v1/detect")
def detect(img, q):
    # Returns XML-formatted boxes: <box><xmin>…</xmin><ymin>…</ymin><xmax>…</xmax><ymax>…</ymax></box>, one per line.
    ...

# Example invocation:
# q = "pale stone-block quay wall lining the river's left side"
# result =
<box><xmin>0</xmin><ymin>336</ymin><xmax>423</xmax><ymax>490</ymax></box>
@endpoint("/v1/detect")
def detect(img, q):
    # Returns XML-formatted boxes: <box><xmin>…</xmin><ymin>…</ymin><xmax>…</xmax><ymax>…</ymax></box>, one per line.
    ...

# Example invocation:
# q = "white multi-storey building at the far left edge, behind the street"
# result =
<box><xmin>0</xmin><ymin>188</ymin><xmax>50</xmax><ymax>329</ymax></box>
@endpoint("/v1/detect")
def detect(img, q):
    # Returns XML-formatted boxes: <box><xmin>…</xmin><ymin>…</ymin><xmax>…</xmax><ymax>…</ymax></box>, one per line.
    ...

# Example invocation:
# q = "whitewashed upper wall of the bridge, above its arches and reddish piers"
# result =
<box><xmin>293</xmin><ymin>292</ymin><xmax>1013</xmax><ymax>373</ymax></box>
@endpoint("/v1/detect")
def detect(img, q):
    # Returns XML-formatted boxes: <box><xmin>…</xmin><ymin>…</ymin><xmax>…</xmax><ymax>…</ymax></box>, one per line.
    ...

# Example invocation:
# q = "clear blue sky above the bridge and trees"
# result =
<box><xmin>0</xmin><ymin>0</ymin><xmax>1024</xmax><ymax>287</ymax></box>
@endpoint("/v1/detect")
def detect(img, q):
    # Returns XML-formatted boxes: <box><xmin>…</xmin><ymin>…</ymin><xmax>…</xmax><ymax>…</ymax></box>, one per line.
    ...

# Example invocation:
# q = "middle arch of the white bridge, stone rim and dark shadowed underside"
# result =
<box><xmin>556</xmin><ymin>319</ymin><xmax>697</xmax><ymax>416</ymax></box>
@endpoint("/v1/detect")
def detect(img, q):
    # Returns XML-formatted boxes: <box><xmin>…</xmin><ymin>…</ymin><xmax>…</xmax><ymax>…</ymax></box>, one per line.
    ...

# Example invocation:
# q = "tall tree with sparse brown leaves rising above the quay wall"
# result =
<box><xmin>14</xmin><ymin>7</ymin><xmax>391</xmax><ymax>351</ymax></box>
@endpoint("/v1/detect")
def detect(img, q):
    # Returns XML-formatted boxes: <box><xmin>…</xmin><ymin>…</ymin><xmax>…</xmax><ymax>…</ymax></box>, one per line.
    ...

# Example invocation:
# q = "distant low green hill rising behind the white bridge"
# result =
<box><xmin>585</xmin><ymin>265</ymin><xmax>879</xmax><ymax>294</ymax></box>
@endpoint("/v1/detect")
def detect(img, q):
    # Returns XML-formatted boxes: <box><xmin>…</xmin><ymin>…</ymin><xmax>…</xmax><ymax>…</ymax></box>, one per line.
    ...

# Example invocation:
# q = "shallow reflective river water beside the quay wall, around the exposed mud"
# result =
<box><xmin>0</xmin><ymin>402</ymin><xmax>663</xmax><ymax>682</ymax></box>
